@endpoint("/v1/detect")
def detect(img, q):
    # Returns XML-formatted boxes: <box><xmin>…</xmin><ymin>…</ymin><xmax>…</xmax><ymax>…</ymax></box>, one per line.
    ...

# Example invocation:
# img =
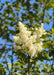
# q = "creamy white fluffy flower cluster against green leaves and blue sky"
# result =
<box><xmin>13</xmin><ymin>22</ymin><xmax>45</xmax><ymax>56</ymax></box>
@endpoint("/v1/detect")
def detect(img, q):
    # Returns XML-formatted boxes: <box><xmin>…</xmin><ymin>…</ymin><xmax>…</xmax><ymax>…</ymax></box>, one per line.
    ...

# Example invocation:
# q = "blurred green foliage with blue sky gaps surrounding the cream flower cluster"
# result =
<box><xmin>0</xmin><ymin>0</ymin><xmax>54</xmax><ymax>75</ymax></box>
